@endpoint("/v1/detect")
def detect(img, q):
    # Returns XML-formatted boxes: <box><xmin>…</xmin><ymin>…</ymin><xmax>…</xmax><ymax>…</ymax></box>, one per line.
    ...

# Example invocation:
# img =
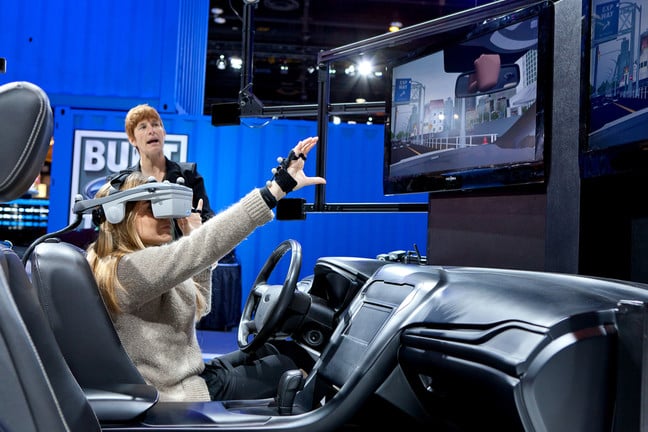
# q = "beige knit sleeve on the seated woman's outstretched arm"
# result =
<box><xmin>117</xmin><ymin>189</ymin><xmax>274</xmax><ymax>311</ymax></box>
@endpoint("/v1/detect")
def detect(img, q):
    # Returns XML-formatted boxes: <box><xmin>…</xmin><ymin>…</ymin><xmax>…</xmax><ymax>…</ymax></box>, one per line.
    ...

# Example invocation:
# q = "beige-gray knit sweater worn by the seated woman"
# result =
<box><xmin>113</xmin><ymin>189</ymin><xmax>274</xmax><ymax>401</ymax></box>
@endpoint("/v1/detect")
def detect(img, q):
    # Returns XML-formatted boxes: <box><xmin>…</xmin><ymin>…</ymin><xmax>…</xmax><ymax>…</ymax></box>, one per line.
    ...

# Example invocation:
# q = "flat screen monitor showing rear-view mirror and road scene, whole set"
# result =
<box><xmin>383</xmin><ymin>2</ymin><xmax>553</xmax><ymax>195</ymax></box>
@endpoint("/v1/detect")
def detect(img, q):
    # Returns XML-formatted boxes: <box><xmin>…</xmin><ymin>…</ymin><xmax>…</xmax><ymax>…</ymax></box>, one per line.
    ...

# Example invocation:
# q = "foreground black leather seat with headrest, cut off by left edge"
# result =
<box><xmin>0</xmin><ymin>82</ymin><xmax>100</xmax><ymax>432</ymax></box>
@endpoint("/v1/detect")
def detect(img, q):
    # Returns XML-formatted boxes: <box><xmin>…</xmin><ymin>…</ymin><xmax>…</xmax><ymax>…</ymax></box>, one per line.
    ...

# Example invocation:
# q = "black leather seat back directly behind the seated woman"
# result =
<box><xmin>30</xmin><ymin>239</ymin><xmax>145</xmax><ymax>388</ymax></box>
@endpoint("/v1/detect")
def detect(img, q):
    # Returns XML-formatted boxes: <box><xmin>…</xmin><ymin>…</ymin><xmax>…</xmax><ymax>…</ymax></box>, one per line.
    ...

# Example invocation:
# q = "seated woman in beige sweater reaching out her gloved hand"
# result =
<box><xmin>88</xmin><ymin>137</ymin><xmax>326</xmax><ymax>401</ymax></box>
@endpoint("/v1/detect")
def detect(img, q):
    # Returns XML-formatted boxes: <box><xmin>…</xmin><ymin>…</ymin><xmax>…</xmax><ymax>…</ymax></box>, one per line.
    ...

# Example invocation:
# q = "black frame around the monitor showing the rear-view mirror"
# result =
<box><xmin>383</xmin><ymin>1</ymin><xmax>554</xmax><ymax>197</ymax></box>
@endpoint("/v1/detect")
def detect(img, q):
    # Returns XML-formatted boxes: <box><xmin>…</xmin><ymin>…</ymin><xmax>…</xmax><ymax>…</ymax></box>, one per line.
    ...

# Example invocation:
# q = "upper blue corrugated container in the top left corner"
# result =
<box><xmin>0</xmin><ymin>0</ymin><xmax>209</xmax><ymax>112</ymax></box>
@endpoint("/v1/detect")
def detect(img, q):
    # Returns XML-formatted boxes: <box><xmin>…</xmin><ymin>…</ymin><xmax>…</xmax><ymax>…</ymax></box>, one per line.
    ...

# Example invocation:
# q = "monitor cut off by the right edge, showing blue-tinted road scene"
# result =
<box><xmin>580</xmin><ymin>0</ymin><xmax>648</xmax><ymax>179</ymax></box>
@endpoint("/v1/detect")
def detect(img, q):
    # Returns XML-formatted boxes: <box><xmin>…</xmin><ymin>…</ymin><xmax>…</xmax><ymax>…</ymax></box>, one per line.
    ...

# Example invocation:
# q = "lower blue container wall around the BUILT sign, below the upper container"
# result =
<box><xmin>48</xmin><ymin>111</ymin><xmax>427</xmax><ymax>308</ymax></box>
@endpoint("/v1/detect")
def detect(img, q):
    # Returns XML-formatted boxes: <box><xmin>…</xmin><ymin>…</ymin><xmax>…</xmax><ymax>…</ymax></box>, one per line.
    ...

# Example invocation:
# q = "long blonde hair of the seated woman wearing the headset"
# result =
<box><xmin>87</xmin><ymin>171</ymin><xmax>206</xmax><ymax>316</ymax></box>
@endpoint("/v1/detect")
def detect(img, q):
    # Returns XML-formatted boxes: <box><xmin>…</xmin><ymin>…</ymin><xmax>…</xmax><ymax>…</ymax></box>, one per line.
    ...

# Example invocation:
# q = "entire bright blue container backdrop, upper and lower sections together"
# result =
<box><xmin>0</xmin><ymin>0</ymin><xmax>427</xmax><ymax>308</ymax></box>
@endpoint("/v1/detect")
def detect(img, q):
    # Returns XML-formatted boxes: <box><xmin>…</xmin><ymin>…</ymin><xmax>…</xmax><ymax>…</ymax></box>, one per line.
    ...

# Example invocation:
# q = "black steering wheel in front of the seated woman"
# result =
<box><xmin>237</xmin><ymin>239</ymin><xmax>302</xmax><ymax>352</ymax></box>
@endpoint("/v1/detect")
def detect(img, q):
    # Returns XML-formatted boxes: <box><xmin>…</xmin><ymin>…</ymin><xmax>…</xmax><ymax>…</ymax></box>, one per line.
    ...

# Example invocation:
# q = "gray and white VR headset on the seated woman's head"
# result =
<box><xmin>73</xmin><ymin>181</ymin><xmax>193</xmax><ymax>225</ymax></box>
